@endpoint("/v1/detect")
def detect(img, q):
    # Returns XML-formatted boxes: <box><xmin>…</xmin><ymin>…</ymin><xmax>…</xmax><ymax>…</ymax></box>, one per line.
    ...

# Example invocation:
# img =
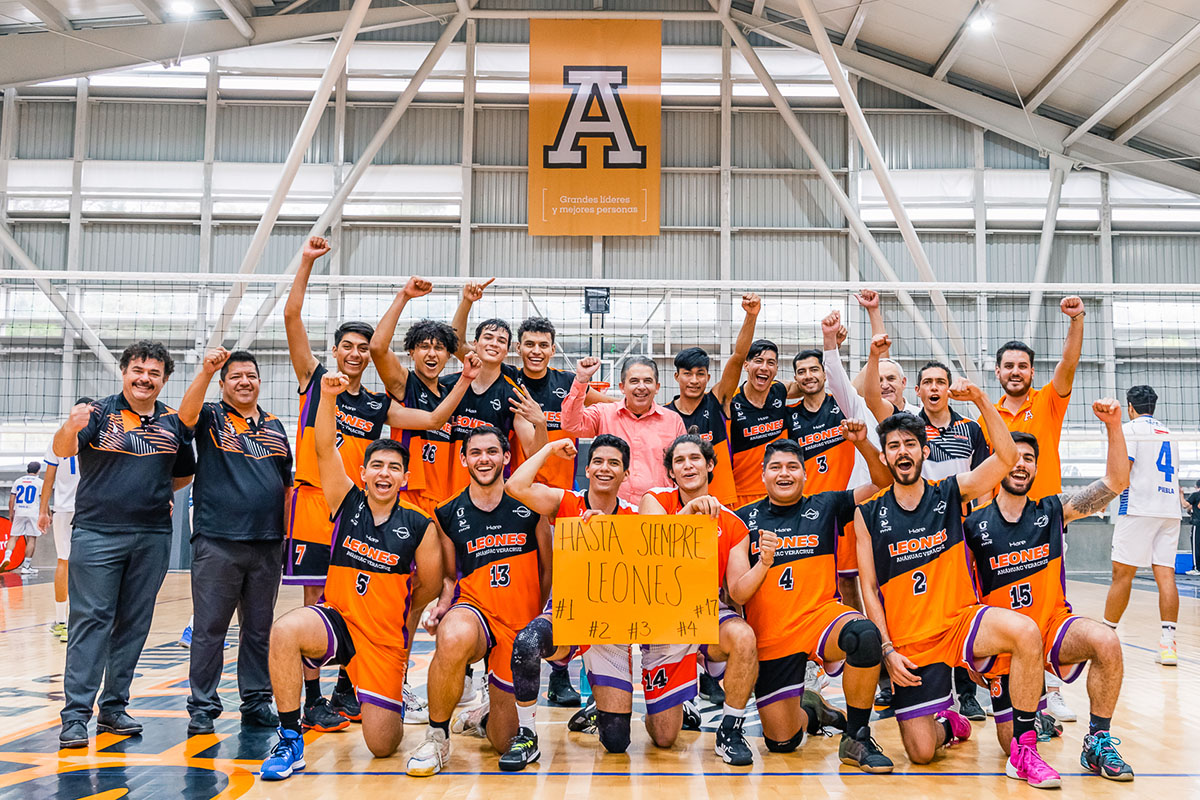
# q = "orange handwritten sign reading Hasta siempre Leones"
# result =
<box><xmin>551</xmin><ymin>515</ymin><xmax>718</xmax><ymax>645</ymax></box>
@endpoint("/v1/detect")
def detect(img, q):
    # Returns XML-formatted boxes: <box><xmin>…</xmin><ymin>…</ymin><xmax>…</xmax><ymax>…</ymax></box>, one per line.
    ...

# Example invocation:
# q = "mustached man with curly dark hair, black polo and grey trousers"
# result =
<box><xmin>53</xmin><ymin>339</ymin><xmax>194</xmax><ymax>747</ymax></box>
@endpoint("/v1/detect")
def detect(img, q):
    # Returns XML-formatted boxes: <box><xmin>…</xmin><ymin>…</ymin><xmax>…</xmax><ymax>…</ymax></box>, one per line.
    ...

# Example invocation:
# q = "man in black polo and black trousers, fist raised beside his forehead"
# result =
<box><xmin>179</xmin><ymin>348</ymin><xmax>292</xmax><ymax>735</ymax></box>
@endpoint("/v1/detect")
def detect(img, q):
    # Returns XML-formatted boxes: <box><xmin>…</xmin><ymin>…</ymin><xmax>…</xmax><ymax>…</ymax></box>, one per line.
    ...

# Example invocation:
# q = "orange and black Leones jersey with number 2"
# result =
<box><xmin>859</xmin><ymin>476</ymin><xmax>979</xmax><ymax>649</ymax></box>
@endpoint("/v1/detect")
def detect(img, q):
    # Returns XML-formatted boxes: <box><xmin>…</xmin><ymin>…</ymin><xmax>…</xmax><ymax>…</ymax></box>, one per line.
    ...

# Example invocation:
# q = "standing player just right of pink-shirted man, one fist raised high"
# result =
<box><xmin>667</xmin><ymin>294</ymin><xmax>762</xmax><ymax>507</ymax></box>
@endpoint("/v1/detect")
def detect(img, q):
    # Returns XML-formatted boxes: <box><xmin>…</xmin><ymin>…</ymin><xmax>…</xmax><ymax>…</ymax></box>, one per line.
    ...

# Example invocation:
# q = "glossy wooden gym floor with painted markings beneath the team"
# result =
<box><xmin>0</xmin><ymin>569</ymin><xmax>1200</xmax><ymax>800</ymax></box>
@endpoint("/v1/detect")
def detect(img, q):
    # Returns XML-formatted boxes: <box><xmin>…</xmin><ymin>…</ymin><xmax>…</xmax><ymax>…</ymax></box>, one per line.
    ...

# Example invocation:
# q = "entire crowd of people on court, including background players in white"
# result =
<box><xmin>28</xmin><ymin>237</ymin><xmax>1180</xmax><ymax>789</ymax></box>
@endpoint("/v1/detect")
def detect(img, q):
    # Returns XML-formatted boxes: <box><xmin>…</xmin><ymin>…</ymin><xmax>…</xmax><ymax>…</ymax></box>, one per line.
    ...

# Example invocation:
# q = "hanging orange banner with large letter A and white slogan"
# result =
<box><xmin>529</xmin><ymin>19</ymin><xmax>662</xmax><ymax>236</ymax></box>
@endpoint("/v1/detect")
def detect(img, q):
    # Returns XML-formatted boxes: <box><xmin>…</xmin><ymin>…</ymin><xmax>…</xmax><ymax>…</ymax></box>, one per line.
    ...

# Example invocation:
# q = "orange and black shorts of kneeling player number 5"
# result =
<box><xmin>304</xmin><ymin>606</ymin><xmax>408</xmax><ymax>714</ymax></box>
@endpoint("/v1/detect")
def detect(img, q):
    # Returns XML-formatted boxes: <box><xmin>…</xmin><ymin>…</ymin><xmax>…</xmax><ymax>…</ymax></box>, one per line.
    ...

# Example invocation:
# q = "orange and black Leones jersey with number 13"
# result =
<box><xmin>437</xmin><ymin>488</ymin><xmax>542</xmax><ymax>631</ymax></box>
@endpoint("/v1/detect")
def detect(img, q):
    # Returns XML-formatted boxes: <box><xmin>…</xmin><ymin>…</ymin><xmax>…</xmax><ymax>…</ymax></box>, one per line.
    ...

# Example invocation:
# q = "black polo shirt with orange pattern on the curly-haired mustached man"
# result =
<box><xmin>74</xmin><ymin>393</ymin><xmax>196</xmax><ymax>534</ymax></box>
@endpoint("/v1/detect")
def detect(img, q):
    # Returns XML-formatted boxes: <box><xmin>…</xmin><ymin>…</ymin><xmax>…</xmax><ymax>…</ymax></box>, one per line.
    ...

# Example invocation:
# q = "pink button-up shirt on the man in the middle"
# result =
<box><xmin>563</xmin><ymin>380</ymin><xmax>688</xmax><ymax>505</ymax></box>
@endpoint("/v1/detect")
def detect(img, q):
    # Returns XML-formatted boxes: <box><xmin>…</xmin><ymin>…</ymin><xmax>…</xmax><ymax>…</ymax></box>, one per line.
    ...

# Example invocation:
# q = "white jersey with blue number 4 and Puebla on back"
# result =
<box><xmin>1117</xmin><ymin>414</ymin><xmax>1180</xmax><ymax>518</ymax></box>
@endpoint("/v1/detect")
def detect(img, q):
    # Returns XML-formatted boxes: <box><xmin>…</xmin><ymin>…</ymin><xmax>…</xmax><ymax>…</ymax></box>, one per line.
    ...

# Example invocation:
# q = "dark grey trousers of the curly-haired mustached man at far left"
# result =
<box><xmin>62</xmin><ymin>528</ymin><xmax>170</xmax><ymax>723</ymax></box>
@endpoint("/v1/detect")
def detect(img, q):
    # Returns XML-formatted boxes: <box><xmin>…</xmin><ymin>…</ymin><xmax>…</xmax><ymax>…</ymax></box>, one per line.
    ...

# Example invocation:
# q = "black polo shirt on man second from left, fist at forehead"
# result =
<box><xmin>192</xmin><ymin>401</ymin><xmax>292</xmax><ymax>541</ymax></box>
